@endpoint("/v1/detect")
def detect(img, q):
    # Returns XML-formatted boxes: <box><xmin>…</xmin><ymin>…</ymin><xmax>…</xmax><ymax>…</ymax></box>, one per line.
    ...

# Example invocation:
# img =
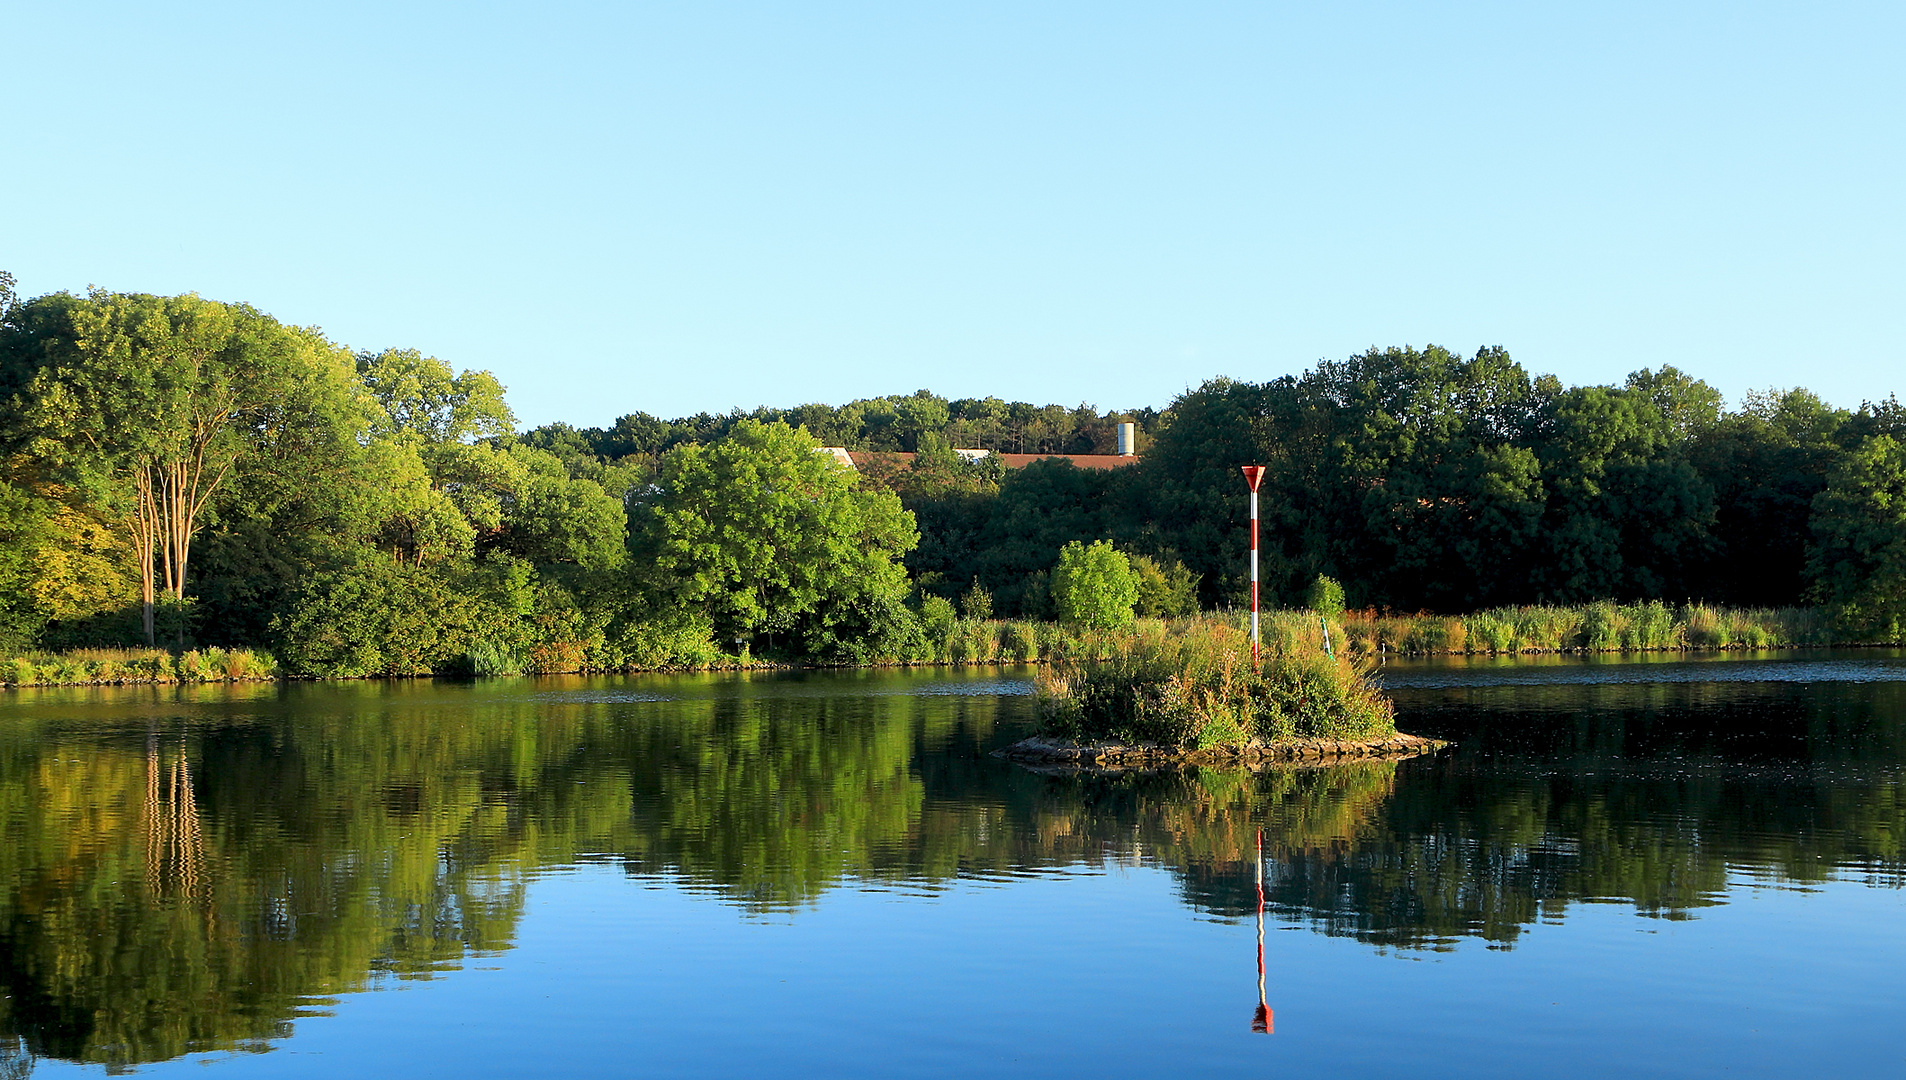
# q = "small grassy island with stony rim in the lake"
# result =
<box><xmin>999</xmin><ymin>617</ymin><xmax>1449</xmax><ymax>770</ymax></box>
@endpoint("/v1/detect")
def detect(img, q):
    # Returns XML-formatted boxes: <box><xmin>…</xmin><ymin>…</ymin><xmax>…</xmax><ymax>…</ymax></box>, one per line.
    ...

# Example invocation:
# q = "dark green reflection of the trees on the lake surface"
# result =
<box><xmin>0</xmin><ymin>672</ymin><xmax>1906</xmax><ymax>1078</ymax></box>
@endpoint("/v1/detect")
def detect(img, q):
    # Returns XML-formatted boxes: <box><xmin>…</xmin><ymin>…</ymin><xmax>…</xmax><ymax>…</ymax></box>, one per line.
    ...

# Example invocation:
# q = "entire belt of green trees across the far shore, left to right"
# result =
<box><xmin>0</xmin><ymin>280</ymin><xmax>1906</xmax><ymax>674</ymax></box>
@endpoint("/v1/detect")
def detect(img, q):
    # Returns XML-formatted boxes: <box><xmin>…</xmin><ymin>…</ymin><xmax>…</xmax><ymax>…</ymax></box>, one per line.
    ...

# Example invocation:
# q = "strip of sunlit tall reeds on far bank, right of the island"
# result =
<box><xmin>1342</xmin><ymin>600</ymin><xmax>1835</xmax><ymax>653</ymax></box>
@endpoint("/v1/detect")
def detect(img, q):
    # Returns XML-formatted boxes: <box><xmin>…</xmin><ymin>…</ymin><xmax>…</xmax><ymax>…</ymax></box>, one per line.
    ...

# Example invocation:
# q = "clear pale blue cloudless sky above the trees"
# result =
<box><xmin>0</xmin><ymin>0</ymin><xmax>1906</xmax><ymax>425</ymax></box>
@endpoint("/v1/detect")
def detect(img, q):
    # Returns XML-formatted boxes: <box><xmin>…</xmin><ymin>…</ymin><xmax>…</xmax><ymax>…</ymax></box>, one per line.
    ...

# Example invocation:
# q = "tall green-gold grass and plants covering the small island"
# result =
<box><xmin>1037</xmin><ymin>617</ymin><xmax>1397</xmax><ymax>749</ymax></box>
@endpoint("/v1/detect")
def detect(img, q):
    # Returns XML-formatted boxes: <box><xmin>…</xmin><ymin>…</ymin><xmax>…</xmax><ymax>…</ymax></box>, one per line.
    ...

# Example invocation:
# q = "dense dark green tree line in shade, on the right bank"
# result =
<box><xmin>907</xmin><ymin>349</ymin><xmax>1906</xmax><ymax>636</ymax></box>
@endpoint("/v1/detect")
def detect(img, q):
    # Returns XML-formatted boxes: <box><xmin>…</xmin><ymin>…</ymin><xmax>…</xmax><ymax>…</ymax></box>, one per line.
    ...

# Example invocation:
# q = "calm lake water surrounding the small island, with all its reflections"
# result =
<box><xmin>0</xmin><ymin>650</ymin><xmax>1906</xmax><ymax>1080</ymax></box>
